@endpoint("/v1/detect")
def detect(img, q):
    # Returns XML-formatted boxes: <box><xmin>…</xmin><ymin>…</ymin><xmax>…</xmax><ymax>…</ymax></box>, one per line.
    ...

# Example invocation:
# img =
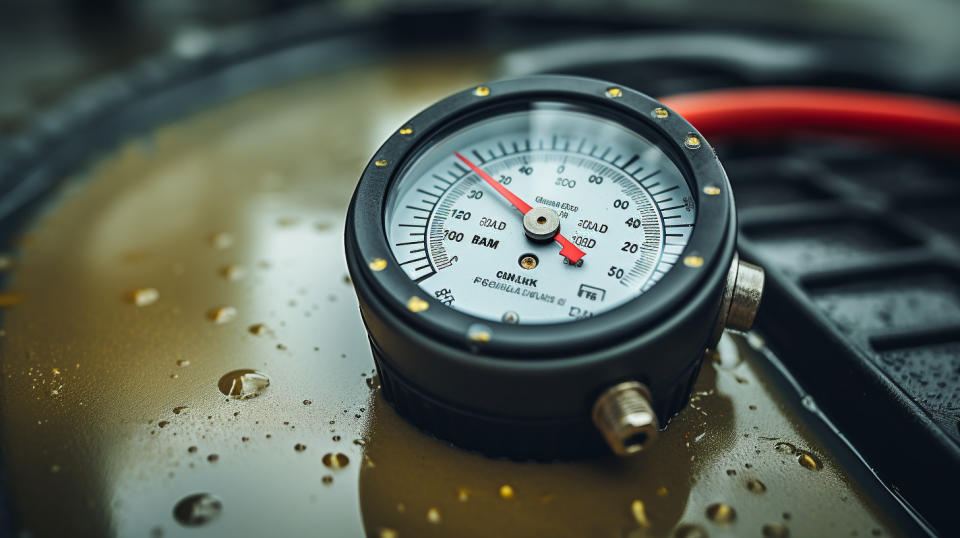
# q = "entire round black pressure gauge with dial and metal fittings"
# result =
<box><xmin>346</xmin><ymin>76</ymin><xmax>763</xmax><ymax>459</ymax></box>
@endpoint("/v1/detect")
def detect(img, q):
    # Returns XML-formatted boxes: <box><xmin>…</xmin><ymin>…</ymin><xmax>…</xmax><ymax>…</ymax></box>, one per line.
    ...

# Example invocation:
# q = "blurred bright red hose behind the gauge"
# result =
<box><xmin>662</xmin><ymin>88</ymin><xmax>960</xmax><ymax>149</ymax></box>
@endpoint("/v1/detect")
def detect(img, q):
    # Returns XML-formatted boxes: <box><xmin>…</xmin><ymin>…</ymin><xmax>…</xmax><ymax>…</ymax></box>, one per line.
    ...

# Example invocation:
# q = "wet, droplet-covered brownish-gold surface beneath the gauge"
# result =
<box><xmin>0</xmin><ymin>54</ymin><xmax>920</xmax><ymax>537</ymax></box>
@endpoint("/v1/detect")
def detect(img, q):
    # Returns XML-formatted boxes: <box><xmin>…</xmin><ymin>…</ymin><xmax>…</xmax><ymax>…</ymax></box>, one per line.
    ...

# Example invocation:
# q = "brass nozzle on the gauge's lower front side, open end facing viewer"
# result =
<box><xmin>593</xmin><ymin>381</ymin><xmax>658</xmax><ymax>456</ymax></box>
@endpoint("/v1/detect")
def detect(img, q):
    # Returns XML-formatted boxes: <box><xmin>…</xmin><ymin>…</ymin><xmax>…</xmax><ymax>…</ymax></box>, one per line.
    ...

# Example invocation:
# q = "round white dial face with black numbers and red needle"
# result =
<box><xmin>384</xmin><ymin>103</ymin><xmax>696</xmax><ymax>324</ymax></box>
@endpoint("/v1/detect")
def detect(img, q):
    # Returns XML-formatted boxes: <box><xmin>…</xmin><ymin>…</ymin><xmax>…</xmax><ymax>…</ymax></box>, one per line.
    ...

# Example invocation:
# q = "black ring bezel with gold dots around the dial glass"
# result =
<box><xmin>347</xmin><ymin>75</ymin><xmax>733</xmax><ymax>359</ymax></box>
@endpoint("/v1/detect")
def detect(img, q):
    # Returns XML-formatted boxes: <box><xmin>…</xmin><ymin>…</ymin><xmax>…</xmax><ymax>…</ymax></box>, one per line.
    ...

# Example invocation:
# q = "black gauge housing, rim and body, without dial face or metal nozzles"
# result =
<box><xmin>345</xmin><ymin>76</ymin><xmax>736</xmax><ymax>459</ymax></box>
